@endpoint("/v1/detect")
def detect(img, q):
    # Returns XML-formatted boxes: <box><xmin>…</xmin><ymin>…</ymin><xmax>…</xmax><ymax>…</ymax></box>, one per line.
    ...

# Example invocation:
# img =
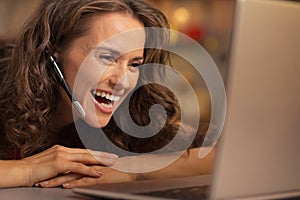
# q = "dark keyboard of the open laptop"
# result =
<box><xmin>139</xmin><ymin>186</ymin><xmax>208</xmax><ymax>200</ymax></box>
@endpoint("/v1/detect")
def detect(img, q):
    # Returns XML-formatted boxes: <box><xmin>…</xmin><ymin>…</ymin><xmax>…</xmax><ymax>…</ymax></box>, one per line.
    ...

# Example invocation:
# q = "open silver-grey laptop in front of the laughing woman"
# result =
<box><xmin>73</xmin><ymin>0</ymin><xmax>300</xmax><ymax>200</ymax></box>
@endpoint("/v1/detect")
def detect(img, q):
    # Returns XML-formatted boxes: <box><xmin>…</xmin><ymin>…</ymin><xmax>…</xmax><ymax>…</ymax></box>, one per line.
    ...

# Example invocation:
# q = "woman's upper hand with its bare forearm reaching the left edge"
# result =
<box><xmin>0</xmin><ymin>145</ymin><xmax>117</xmax><ymax>188</ymax></box>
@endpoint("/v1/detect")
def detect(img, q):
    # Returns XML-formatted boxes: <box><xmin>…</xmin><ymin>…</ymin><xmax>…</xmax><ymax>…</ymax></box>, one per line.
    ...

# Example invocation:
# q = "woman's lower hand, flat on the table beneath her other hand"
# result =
<box><xmin>36</xmin><ymin>166</ymin><xmax>137</xmax><ymax>188</ymax></box>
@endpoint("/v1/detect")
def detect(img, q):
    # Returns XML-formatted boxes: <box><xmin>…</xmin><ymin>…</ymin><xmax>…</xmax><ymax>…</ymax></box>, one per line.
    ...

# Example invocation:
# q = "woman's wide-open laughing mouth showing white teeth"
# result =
<box><xmin>91</xmin><ymin>90</ymin><xmax>120</xmax><ymax>108</ymax></box>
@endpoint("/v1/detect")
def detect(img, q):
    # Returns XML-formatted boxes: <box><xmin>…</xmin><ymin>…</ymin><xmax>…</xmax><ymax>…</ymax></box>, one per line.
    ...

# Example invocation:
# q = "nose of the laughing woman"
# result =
<box><xmin>109</xmin><ymin>62</ymin><xmax>130</xmax><ymax>90</ymax></box>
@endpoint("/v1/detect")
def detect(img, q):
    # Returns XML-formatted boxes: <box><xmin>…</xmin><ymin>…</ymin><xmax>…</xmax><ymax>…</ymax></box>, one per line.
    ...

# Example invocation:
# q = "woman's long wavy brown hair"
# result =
<box><xmin>0</xmin><ymin>0</ymin><xmax>202</xmax><ymax>158</ymax></box>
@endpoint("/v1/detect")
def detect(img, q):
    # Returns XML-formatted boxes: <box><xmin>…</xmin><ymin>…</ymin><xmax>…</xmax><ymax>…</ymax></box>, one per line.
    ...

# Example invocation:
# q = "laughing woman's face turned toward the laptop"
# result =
<box><xmin>56</xmin><ymin>13</ymin><xmax>146</xmax><ymax>127</ymax></box>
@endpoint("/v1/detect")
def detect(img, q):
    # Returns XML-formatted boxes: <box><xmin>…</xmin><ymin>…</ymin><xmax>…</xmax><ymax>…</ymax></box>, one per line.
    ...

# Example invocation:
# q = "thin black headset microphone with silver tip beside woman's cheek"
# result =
<box><xmin>49</xmin><ymin>55</ymin><xmax>85</xmax><ymax>117</ymax></box>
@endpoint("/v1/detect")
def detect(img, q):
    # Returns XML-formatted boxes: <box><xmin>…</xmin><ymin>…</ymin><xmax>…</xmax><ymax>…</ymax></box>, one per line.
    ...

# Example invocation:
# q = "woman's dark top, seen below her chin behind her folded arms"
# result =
<box><xmin>0</xmin><ymin>120</ymin><xmax>203</xmax><ymax>160</ymax></box>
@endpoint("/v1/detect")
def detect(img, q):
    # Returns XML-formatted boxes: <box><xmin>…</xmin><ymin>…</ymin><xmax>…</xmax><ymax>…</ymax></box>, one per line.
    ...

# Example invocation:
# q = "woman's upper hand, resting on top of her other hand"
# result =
<box><xmin>22</xmin><ymin>145</ymin><xmax>117</xmax><ymax>186</ymax></box>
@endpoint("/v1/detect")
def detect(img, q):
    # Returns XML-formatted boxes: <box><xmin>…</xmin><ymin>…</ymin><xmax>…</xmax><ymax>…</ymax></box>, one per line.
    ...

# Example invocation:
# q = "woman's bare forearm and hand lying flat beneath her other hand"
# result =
<box><xmin>40</xmin><ymin>148</ymin><xmax>215</xmax><ymax>188</ymax></box>
